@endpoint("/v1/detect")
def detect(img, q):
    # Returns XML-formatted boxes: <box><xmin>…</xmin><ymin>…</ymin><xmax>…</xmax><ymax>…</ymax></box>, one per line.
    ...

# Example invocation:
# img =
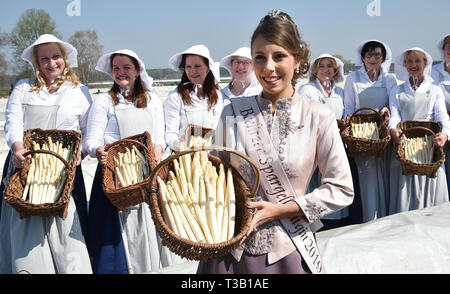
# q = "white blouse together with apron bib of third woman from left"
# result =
<box><xmin>163</xmin><ymin>89</ymin><xmax>224</xmax><ymax>150</ymax></box>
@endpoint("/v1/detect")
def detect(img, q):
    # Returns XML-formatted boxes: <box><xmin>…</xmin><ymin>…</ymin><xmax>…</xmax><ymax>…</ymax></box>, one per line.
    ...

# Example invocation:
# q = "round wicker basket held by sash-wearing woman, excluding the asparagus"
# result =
<box><xmin>147</xmin><ymin>146</ymin><xmax>259</xmax><ymax>260</ymax></box>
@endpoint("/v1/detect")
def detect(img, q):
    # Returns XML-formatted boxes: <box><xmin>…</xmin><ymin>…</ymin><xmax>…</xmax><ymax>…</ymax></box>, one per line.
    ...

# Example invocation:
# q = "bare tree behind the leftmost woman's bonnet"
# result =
<box><xmin>9</xmin><ymin>8</ymin><xmax>62</xmax><ymax>77</ymax></box>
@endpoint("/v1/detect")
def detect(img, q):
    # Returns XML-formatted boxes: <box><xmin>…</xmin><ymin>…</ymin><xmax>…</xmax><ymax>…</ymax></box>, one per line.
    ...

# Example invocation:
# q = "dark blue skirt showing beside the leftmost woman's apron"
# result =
<box><xmin>0</xmin><ymin>151</ymin><xmax>88</xmax><ymax>238</ymax></box>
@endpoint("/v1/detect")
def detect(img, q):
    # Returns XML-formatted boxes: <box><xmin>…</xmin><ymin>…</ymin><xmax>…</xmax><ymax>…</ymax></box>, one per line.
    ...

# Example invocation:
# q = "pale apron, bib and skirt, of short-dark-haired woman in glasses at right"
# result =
<box><xmin>354</xmin><ymin>71</ymin><xmax>392</xmax><ymax>222</ymax></box>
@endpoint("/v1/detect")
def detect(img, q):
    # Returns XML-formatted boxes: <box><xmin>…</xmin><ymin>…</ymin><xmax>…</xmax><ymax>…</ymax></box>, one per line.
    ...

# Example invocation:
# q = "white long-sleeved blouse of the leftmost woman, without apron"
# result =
<box><xmin>5</xmin><ymin>78</ymin><xmax>92</xmax><ymax>153</ymax></box>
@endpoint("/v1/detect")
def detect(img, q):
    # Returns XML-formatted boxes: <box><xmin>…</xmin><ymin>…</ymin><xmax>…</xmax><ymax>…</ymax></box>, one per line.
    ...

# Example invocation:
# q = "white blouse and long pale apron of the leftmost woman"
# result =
<box><xmin>0</xmin><ymin>79</ymin><xmax>92</xmax><ymax>274</ymax></box>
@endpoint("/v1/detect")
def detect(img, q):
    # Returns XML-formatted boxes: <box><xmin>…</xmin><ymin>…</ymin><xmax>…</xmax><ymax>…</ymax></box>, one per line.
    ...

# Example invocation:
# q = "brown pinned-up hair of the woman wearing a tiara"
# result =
<box><xmin>251</xmin><ymin>10</ymin><xmax>310</xmax><ymax>86</ymax></box>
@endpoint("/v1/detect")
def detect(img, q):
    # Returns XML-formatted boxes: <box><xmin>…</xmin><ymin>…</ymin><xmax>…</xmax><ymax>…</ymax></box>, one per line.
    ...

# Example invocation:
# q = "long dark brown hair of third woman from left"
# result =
<box><xmin>177</xmin><ymin>54</ymin><xmax>219</xmax><ymax>110</ymax></box>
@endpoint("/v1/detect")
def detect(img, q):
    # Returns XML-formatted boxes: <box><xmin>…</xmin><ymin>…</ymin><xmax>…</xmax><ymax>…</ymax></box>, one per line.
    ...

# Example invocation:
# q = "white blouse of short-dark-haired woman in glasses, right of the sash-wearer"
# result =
<box><xmin>344</xmin><ymin>66</ymin><xmax>397</xmax><ymax>117</ymax></box>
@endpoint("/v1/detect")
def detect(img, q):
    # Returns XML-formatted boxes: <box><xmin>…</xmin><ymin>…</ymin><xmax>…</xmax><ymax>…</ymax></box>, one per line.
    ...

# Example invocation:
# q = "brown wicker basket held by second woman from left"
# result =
<box><xmin>102</xmin><ymin>132</ymin><xmax>156</xmax><ymax>212</ymax></box>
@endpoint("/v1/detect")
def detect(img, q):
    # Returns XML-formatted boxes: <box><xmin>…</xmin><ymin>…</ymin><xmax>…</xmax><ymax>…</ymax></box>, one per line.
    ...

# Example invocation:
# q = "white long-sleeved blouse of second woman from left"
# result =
<box><xmin>86</xmin><ymin>93</ymin><xmax>166</xmax><ymax>157</ymax></box>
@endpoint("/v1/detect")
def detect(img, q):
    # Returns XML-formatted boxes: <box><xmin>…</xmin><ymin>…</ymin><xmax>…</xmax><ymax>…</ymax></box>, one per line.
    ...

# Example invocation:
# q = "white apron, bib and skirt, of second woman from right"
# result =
<box><xmin>389</xmin><ymin>82</ymin><xmax>449</xmax><ymax>214</ymax></box>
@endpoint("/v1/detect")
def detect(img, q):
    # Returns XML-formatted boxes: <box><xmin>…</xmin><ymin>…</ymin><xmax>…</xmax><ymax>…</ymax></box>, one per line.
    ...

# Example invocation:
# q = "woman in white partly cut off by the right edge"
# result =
<box><xmin>431</xmin><ymin>34</ymin><xmax>450</xmax><ymax>190</ymax></box>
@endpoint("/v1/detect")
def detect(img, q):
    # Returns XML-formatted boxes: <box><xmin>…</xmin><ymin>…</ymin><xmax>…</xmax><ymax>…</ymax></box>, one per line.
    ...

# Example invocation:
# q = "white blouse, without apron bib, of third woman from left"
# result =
<box><xmin>163</xmin><ymin>89</ymin><xmax>223</xmax><ymax>150</ymax></box>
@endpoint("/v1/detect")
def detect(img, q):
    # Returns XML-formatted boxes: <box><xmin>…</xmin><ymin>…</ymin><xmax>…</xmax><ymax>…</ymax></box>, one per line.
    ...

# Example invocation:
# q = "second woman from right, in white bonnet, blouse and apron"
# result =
<box><xmin>389</xmin><ymin>48</ymin><xmax>450</xmax><ymax>214</ymax></box>
